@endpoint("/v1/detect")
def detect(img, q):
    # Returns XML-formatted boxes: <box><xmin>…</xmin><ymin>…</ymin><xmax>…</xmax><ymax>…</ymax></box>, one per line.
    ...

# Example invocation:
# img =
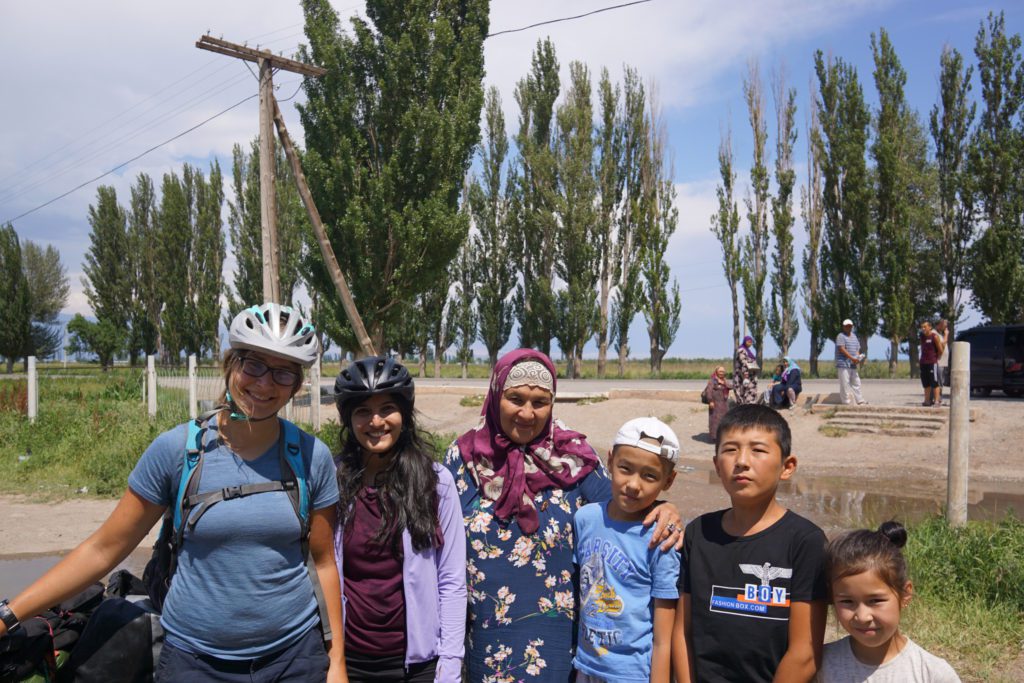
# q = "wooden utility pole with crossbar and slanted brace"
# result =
<box><xmin>196</xmin><ymin>36</ymin><xmax>377</xmax><ymax>355</ymax></box>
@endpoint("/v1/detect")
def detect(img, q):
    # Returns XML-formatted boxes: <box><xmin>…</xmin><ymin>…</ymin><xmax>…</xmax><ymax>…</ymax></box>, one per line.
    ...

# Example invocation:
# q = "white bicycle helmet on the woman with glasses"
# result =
<box><xmin>227</xmin><ymin>303</ymin><xmax>319</xmax><ymax>368</ymax></box>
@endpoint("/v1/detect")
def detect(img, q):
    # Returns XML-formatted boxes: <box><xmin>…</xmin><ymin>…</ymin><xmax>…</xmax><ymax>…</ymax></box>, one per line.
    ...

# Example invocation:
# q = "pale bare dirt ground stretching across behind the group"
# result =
<box><xmin>0</xmin><ymin>382</ymin><xmax>1024</xmax><ymax>557</ymax></box>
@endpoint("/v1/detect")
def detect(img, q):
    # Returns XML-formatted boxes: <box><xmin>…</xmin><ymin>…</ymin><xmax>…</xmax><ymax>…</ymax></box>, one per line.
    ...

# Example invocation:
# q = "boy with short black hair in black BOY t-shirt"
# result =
<box><xmin>672</xmin><ymin>404</ymin><xmax>827</xmax><ymax>683</ymax></box>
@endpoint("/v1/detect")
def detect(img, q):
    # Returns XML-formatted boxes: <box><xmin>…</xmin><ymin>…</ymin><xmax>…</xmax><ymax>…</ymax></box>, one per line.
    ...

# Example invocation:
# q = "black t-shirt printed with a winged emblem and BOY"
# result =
<box><xmin>679</xmin><ymin>510</ymin><xmax>827</xmax><ymax>683</ymax></box>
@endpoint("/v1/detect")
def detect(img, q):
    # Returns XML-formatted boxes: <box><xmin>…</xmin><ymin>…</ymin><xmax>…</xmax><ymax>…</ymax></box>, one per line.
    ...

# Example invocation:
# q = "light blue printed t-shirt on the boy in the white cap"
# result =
<box><xmin>572</xmin><ymin>503</ymin><xmax>679</xmax><ymax>682</ymax></box>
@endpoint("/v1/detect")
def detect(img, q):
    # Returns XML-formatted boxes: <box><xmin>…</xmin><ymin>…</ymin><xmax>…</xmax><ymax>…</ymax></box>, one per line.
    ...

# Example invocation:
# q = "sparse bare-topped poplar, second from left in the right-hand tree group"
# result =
<box><xmin>740</xmin><ymin>62</ymin><xmax>771</xmax><ymax>365</ymax></box>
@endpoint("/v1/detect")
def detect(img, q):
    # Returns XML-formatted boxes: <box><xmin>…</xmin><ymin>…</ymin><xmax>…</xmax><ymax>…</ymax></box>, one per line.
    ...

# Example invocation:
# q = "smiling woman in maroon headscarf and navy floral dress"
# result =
<box><xmin>444</xmin><ymin>349</ymin><xmax>681</xmax><ymax>683</ymax></box>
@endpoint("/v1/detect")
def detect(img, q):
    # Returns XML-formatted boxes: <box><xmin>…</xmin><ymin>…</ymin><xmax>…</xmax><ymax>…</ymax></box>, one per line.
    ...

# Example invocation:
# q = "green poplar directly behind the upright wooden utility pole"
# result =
<box><xmin>224</xmin><ymin>137</ymin><xmax>305</xmax><ymax>325</ymax></box>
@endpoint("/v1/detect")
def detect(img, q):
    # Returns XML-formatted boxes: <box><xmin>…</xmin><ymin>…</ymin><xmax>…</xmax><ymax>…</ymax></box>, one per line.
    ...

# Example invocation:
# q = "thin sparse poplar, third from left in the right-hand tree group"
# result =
<box><xmin>768</xmin><ymin>71</ymin><xmax>800</xmax><ymax>355</ymax></box>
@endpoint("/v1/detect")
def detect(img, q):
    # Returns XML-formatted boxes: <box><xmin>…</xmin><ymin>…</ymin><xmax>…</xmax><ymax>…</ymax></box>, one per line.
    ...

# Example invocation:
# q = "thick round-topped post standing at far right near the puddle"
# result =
<box><xmin>946</xmin><ymin>342</ymin><xmax>971</xmax><ymax>526</ymax></box>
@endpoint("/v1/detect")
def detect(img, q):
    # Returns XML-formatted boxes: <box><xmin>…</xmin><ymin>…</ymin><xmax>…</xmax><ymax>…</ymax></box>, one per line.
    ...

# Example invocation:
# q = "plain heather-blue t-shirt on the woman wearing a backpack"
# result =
<box><xmin>128</xmin><ymin>419</ymin><xmax>338</xmax><ymax>659</ymax></box>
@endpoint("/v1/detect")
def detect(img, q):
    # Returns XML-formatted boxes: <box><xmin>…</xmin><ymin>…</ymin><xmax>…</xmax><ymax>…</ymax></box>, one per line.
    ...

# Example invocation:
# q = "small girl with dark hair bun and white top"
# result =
<box><xmin>816</xmin><ymin>521</ymin><xmax>959</xmax><ymax>683</ymax></box>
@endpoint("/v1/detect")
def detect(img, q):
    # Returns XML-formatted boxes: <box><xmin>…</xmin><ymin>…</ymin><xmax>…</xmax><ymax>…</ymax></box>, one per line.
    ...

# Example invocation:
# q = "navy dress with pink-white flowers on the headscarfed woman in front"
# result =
<box><xmin>444</xmin><ymin>443</ymin><xmax>611</xmax><ymax>683</ymax></box>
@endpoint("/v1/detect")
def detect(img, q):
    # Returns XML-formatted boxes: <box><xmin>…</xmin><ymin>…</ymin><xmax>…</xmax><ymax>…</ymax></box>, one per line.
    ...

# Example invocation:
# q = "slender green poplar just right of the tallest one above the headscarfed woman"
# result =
<box><xmin>555</xmin><ymin>61</ymin><xmax>601</xmax><ymax>378</ymax></box>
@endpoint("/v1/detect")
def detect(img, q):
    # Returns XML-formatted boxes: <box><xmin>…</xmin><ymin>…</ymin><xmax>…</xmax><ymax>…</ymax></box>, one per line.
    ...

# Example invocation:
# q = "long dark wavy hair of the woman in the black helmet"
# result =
<box><xmin>338</xmin><ymin>393</ymin><xmax>441</xmax><ymax>556</ymax></box>
